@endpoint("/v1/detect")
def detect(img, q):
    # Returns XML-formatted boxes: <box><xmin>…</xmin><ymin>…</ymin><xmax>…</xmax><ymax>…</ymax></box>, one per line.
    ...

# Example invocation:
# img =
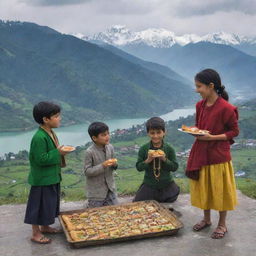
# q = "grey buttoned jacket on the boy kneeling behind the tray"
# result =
<box><xmin>84</xmin><ymin>143</ymin><xmax>116</xmax><ymax>200</ymax></box>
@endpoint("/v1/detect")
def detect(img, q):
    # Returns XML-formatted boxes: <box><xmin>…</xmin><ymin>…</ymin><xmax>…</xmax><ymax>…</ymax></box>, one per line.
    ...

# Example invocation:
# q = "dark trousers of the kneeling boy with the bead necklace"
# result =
<box><xmin>133</xmin><ymin>181</ymin><xmax>180</xmax><ymax>203</ymax></box>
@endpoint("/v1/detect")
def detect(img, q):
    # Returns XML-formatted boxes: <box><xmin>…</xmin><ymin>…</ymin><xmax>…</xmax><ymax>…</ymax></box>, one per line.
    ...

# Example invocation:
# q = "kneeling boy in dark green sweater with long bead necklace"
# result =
<box><xmin>133</xmin><ymin>117</ymin><xmax>180</xmax><ymax>202</ymax></box>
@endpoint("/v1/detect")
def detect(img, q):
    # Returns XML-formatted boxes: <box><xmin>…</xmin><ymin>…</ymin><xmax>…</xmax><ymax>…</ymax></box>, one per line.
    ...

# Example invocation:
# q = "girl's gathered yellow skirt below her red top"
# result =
<box><xmin>190</xmin><ymin>161</ymin><xmax>237</xmax><ymax>211</ymax></box>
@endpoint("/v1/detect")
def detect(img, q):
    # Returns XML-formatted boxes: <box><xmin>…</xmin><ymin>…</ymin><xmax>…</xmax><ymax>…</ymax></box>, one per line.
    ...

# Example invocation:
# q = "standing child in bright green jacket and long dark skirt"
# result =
<box><xmin>24</xmin><ymin>102</ymin><xmax>66</xmax><ymax>244</ymax></box>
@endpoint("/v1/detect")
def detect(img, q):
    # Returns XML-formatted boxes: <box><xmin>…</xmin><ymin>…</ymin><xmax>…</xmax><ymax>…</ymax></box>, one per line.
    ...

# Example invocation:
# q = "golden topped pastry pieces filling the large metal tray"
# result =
<box><xmin>61</xmin><ymin>203</ymin><xmax>176</xmax><ymax>242</ymax></box>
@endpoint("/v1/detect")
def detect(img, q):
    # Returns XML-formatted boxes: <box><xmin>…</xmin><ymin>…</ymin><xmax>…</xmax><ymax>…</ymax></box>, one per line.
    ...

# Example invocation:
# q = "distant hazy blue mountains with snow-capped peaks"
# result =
<box><xmin>80</xmin><ymin>26</ymin><xmax>256</xmax><ymax>99</ymax></box>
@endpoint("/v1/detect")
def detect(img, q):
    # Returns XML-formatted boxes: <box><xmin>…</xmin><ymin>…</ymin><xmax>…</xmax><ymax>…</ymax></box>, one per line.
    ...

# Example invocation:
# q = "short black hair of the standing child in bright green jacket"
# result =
<box><xmin>33</xmin><ymin>101</ymin><xmax>61</xmax><ymax>124</ymax></box>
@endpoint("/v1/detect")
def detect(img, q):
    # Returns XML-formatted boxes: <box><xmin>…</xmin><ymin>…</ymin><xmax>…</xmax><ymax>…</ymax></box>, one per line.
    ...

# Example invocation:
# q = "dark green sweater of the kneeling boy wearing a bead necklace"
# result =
<box><xmin>136</xmin><ymin>142</ymin><xmax>179</xmax><ymax>189</ymax></box>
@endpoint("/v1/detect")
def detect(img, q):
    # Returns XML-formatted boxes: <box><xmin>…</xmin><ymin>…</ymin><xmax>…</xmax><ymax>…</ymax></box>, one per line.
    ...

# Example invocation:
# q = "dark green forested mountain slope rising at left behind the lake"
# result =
<box><xmin>0</xmin><ymin>21</ymin><xmax>193</xmax><ymax>130</ymax></box>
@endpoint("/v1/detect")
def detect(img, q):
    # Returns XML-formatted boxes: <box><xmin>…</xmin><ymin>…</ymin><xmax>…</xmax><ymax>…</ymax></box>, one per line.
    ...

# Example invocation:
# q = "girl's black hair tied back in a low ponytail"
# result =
<box><xmin>195</xmin><ymin>68</ymin><xmax>229</xmax><ymax>101</ymax></box>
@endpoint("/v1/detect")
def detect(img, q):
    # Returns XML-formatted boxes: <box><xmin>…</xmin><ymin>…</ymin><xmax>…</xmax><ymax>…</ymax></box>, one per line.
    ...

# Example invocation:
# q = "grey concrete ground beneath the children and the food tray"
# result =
<box><xmin>0</xmin><ymin>191</ymin><xmax>256</xmax><ymax>256</ymax></box>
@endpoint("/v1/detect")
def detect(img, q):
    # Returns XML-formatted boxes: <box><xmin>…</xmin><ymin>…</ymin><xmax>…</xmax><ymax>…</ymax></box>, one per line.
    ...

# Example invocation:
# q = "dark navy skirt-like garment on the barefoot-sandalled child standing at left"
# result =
<box><xmin>24</xmin><ymin>183</ymin><xmax>60</xmax><ymax>226</ymax></box>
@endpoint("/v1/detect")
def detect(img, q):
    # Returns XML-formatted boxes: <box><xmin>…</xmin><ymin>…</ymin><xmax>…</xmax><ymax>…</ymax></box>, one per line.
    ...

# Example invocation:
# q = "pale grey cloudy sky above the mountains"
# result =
<box><xmin>0</xmin><ymin>0</ymin><xmax>256</xmax><ymax>36</ymax></box>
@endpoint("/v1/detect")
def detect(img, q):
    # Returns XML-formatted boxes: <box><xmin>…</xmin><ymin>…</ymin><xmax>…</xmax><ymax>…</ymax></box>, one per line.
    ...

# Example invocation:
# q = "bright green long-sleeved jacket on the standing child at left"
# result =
<box><xmin>28</xmin><ymin>127</ymin><xmax>61</xmax><ymax>186</ymax></box>
